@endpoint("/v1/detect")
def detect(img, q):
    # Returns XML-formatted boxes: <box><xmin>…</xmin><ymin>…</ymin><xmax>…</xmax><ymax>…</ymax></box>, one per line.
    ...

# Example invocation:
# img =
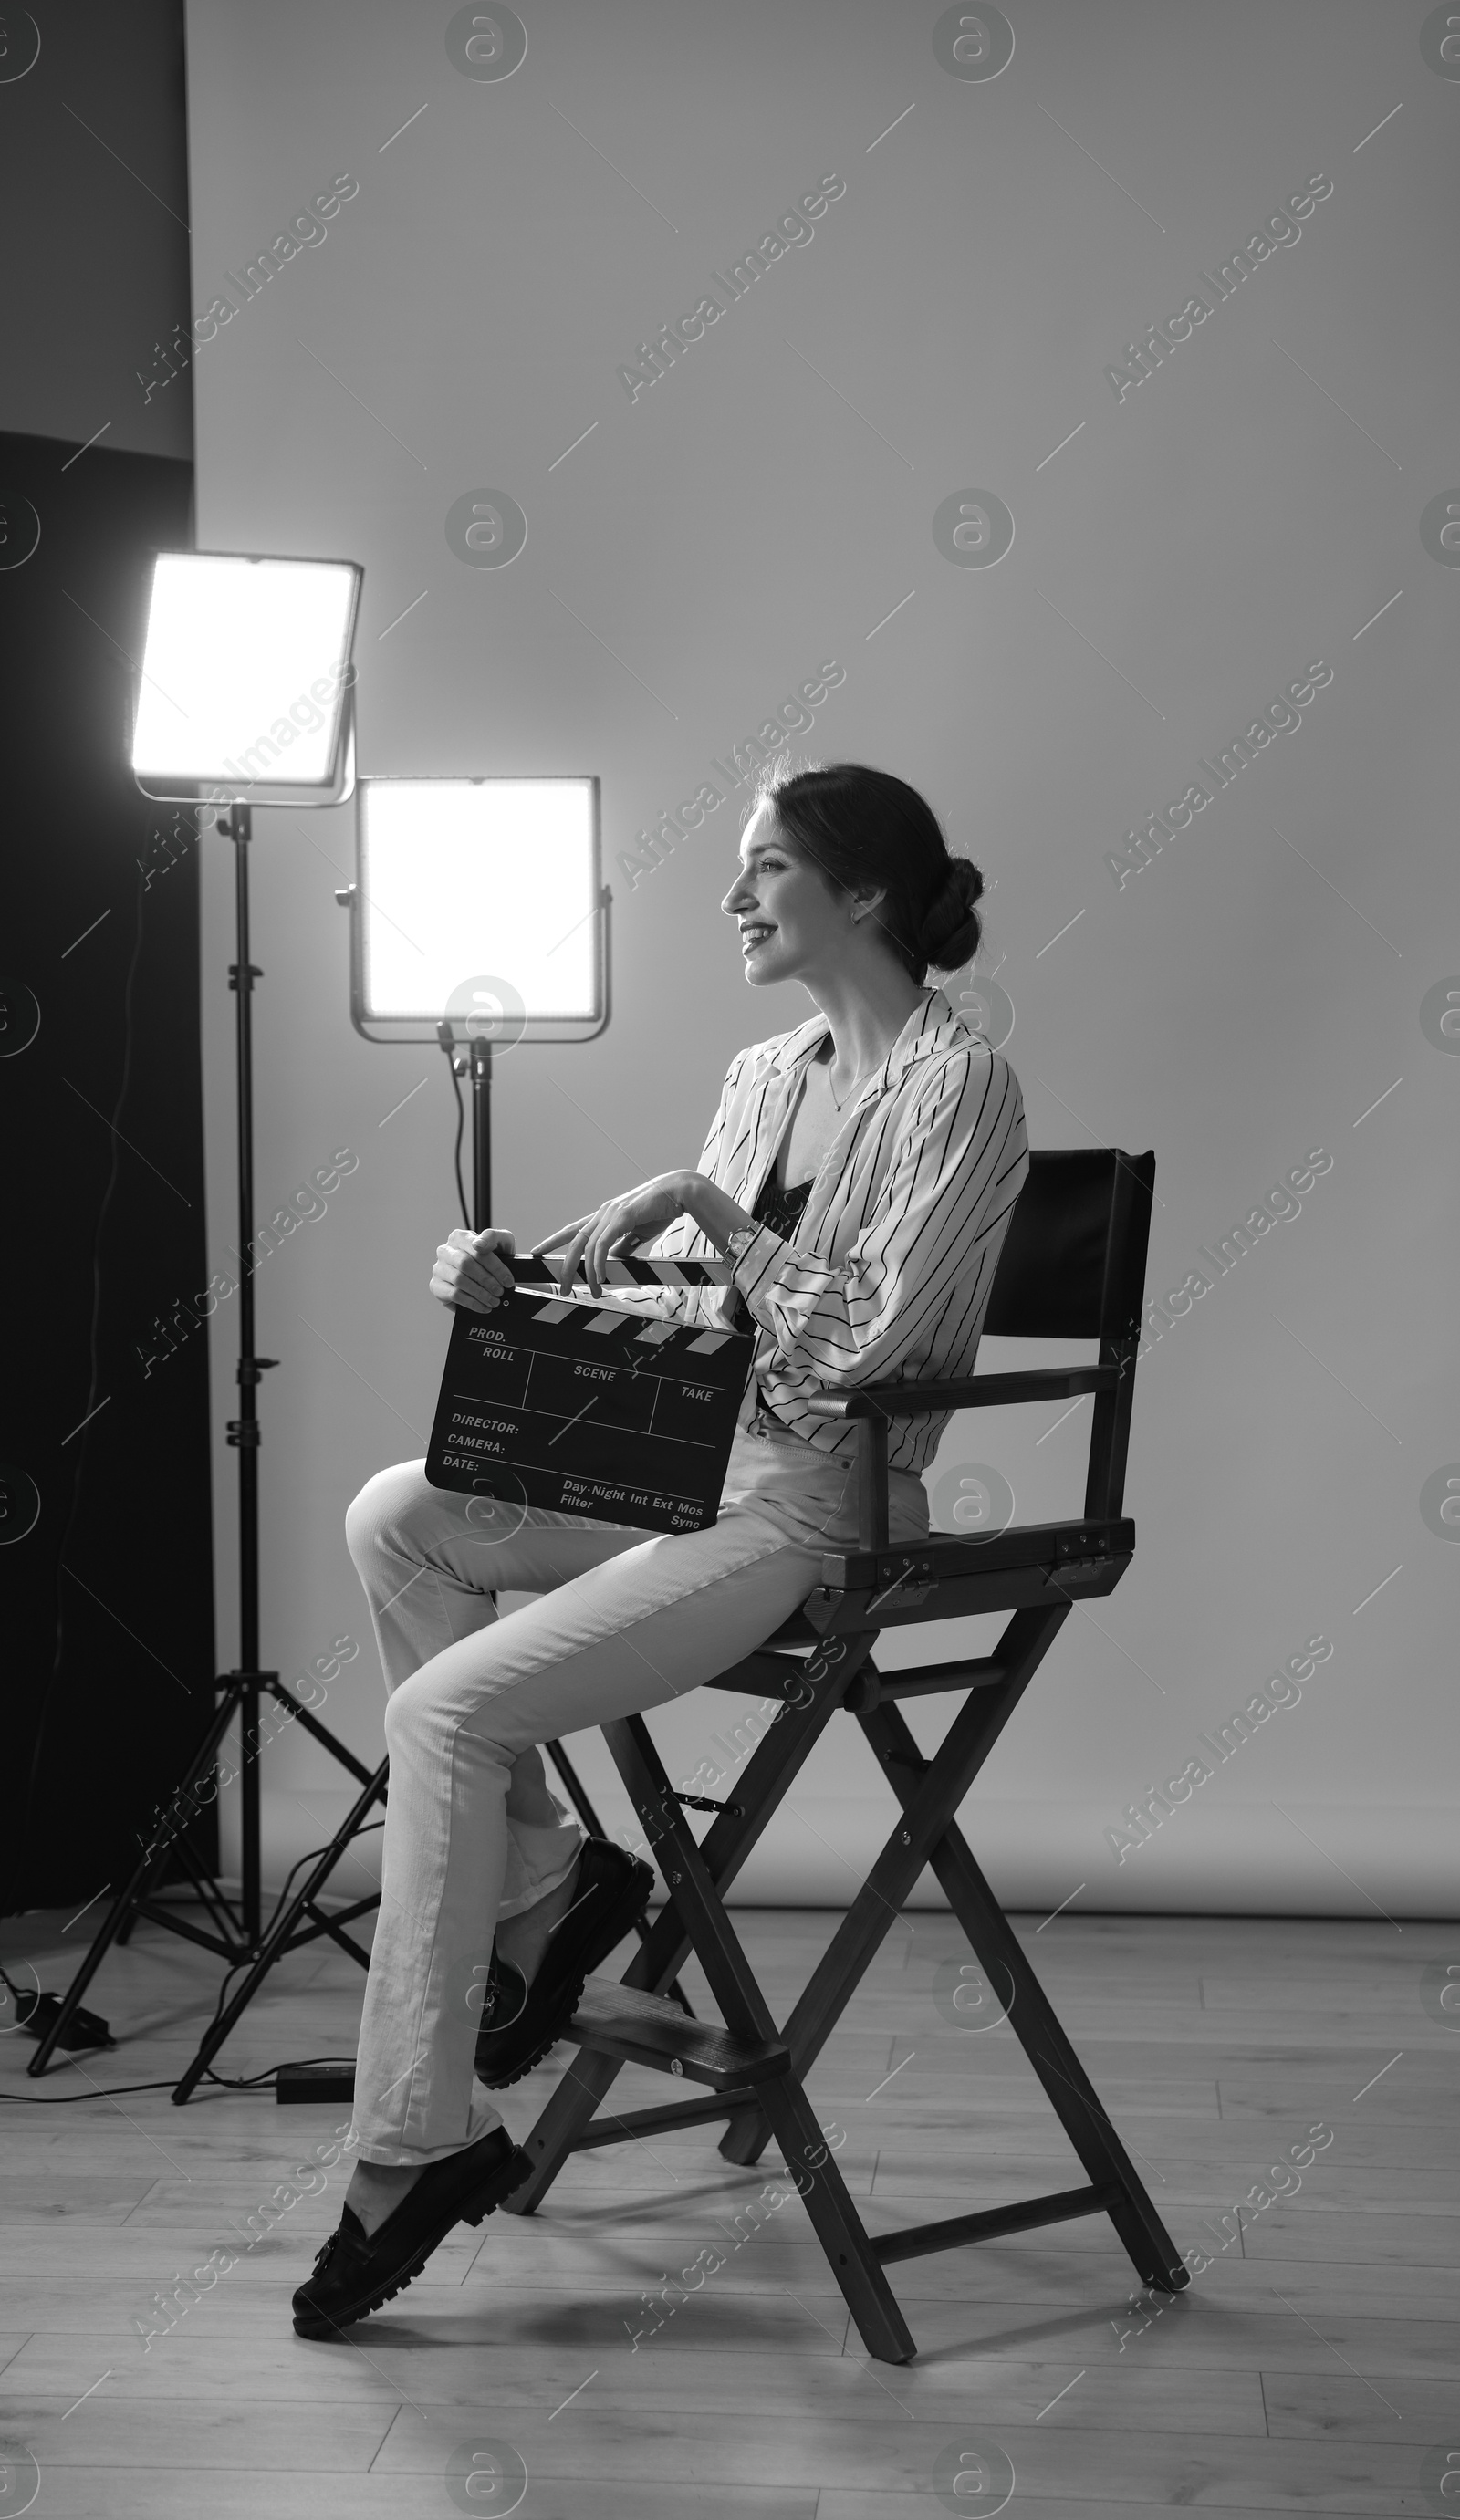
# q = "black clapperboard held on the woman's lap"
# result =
<box><xmin>426</xmin><ymin>1260</ymin><xmax>751</xmax><ymax>1532</ymax></box>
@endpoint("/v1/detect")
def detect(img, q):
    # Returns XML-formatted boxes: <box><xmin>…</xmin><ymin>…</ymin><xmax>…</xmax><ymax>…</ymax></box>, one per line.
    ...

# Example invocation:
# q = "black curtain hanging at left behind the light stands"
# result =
<box><xmin>0</xmin><ymin>433</ymin><xmax>219</xmax><ymax>1915</ymax></box>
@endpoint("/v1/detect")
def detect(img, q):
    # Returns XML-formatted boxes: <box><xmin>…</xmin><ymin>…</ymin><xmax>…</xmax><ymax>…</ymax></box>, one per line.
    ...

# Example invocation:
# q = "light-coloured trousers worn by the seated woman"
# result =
<box><xmin>346</xmin><ymin>1419</ymin><xmax>928</xmax><ymax>2165</ymax></box>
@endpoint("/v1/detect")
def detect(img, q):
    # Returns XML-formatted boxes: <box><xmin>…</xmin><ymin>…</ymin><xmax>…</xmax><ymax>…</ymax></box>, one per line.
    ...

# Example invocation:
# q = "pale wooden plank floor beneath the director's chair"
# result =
<box><xmin>0</xmin><ymin>1911</ymin><xmax>1460</xmax><ymax>2520</ymax></box>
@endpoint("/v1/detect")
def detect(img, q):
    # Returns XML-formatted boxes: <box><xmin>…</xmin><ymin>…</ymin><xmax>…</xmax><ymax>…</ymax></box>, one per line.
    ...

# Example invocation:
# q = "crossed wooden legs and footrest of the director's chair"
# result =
<box><xmin>506</xmin><ymin>1600</ymin><xmax>1190</xmax><ymax>2364</ymax></box>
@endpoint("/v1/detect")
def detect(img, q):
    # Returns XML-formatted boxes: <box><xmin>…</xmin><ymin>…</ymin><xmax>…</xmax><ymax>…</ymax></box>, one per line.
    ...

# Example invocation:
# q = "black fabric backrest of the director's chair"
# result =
<box><xmin>984</xmin><ymin>1147</ymin><xmax>1155</xmax><ymax>1340</ymax></box>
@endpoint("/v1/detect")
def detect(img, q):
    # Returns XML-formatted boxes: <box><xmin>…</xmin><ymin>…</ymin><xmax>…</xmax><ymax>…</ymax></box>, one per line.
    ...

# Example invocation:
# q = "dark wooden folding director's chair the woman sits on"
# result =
<box><xmin>509</xmin><ymin>1147</ymin><xmax>1190</xmax><ymax>2361</ymax></box>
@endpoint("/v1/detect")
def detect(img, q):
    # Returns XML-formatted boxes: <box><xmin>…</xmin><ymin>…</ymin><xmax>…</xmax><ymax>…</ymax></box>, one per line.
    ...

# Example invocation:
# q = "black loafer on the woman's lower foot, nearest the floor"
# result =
<box><xmin>295</xmin><ymin>2127</ymin><xmax>532</xmax><ymax>2338</ymax></box>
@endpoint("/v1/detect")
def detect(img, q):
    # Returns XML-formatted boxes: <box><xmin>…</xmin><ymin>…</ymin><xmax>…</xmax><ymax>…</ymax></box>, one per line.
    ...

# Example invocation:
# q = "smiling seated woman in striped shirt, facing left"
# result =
<box><xmin>295</xmin><ymin>764</ymin><xmax>1028</xmax><ymax>2336</ymax></box>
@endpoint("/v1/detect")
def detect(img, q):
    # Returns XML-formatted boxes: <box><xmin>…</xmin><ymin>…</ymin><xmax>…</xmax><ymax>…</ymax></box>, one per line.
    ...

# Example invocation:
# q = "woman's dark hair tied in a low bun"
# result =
<box><xmin>751</xmin><ymin>761</ymin><xmax>984</xmax><ymax>988</ymax></box>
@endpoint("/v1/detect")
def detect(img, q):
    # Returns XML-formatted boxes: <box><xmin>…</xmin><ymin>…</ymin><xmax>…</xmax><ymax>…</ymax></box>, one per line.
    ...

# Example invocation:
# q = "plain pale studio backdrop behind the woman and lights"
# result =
<box><xmin>189</xmin><ymin>0</ymin><xmax>1460</xmax><ymax>1922</ymax></box>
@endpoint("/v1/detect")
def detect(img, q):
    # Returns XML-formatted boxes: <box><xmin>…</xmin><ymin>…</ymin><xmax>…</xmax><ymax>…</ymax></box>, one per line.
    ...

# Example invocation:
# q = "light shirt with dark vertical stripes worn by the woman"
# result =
<box><xmin>575</xmin><ymin>988</ymin><xmax>1028</xmax><ymax>1472</ymax></box>
